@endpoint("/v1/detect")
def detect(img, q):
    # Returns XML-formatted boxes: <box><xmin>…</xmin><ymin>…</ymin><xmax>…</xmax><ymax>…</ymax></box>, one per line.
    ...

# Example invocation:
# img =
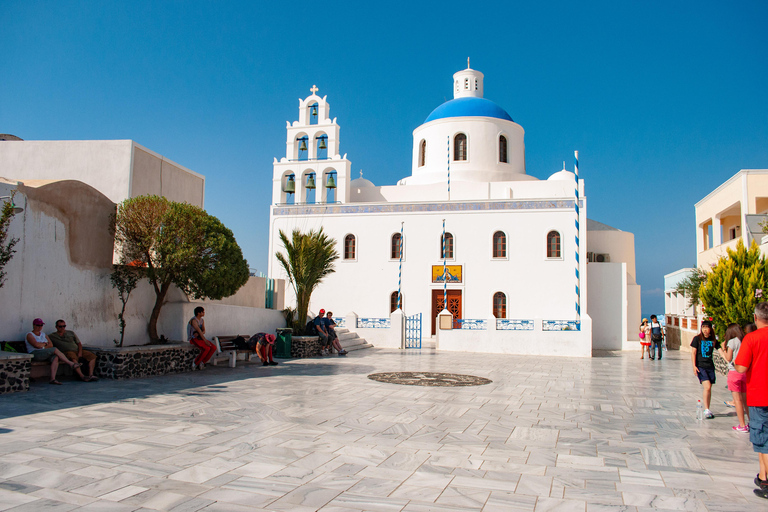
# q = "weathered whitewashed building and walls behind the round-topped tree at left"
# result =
<box><xmin>0</xmin><ymin>135</ymin><xmax>285</xmax><ymax>347</ymax></box>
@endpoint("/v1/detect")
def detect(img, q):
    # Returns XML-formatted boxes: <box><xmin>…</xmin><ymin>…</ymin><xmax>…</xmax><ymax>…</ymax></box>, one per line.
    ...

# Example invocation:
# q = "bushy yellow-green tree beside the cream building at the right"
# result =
<box><xmin>699</xmin><ymin>240</ymin><xmax>768</xmax><ymax>339</ymax></box>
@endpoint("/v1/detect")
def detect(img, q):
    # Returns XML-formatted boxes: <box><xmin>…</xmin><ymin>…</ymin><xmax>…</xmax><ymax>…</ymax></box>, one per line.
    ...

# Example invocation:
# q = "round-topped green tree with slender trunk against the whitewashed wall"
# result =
<box><xmin>114</xmin><ymin>196</ymin><xmax>249</xmax><ymax>341</ymax></box>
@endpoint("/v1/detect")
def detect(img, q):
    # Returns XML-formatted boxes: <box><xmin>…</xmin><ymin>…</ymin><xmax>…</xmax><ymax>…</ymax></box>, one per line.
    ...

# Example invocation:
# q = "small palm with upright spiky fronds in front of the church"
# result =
<box><xmin>275</xmin><ymin>228</ymin><xmax>339</xmax><ymax>327</ymax></box>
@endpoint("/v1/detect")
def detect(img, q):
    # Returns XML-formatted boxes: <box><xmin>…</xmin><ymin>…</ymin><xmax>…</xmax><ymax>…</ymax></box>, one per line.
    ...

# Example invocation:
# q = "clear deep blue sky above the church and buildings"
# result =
<box><xmin>0</xmin><ymin>0</ymin><xmax>768</xmax><ymax>313</ymax></box>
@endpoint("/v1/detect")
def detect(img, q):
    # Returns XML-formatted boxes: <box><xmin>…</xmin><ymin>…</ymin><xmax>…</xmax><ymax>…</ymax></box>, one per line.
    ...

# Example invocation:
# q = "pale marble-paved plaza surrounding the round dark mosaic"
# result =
<box><xmin>0</xmin><ymin>349</ymin><xmax>768</xmax><ymax>512</ymax></box>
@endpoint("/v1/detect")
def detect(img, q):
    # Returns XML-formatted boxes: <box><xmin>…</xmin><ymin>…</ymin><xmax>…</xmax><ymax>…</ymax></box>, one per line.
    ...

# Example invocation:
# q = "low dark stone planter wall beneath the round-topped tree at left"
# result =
<box><xmin>88</xmin><ymin>343</ymin><xmax>200</xmax><ymax>379</ymax></box>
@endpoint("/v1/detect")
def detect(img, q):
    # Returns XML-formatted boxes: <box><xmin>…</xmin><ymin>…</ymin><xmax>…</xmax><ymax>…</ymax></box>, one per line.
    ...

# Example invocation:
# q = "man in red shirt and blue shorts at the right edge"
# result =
<box><xmin>734</xmin><ymin>302</ymin><xmax>768</xmax><ymax>499</ymax></box>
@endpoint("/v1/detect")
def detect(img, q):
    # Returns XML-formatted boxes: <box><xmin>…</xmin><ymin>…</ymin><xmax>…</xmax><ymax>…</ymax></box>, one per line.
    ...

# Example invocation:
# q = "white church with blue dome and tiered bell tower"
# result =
<box><xmin>269</xmin><ymin>68</ymin><xmax>640</xmax><ymax>357</ymax></box>
